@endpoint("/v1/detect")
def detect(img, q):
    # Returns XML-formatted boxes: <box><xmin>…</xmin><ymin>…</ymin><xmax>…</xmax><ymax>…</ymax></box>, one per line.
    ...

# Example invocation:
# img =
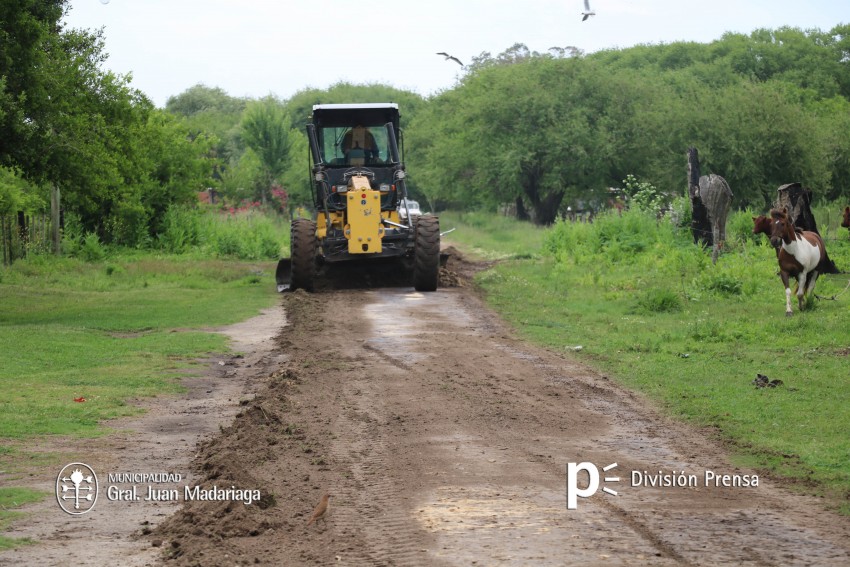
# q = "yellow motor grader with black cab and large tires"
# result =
<box><xmin>276</xmin><ymin>103</ymin><xmax>440</xmax><ymax>291</ymax></box>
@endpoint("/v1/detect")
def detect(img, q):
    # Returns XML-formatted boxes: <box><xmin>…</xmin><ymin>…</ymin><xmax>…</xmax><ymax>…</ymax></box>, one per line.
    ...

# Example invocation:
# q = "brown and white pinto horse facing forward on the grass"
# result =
<box><xmin>770</xmin><ymin>209</ymin><xmax>826</xmax><ymax>317</ymax></box>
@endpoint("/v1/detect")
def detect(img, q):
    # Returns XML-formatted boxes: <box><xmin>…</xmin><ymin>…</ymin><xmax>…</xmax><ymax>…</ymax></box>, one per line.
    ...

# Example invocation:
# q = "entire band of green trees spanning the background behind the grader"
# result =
<box><xmin>0</xmin><ymin>4</ymin><xmax>850</xmax><ymax>245</ymax></box>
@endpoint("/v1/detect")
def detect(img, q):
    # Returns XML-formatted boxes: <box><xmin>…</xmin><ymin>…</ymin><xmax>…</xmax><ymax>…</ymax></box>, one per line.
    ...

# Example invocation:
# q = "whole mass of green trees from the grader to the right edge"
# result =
<box><xmin>410</xmin><ymin>25</ymin><xmax>850</xmax><ymax>223</ymax></box>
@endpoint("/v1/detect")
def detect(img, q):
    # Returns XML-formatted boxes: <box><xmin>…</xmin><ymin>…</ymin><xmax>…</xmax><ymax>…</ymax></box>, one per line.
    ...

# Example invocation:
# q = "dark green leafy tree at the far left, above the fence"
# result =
<box><xmin>0</xmin><ymin>0</ymin><xmax>211</xmax><ymax>245</ymax></box>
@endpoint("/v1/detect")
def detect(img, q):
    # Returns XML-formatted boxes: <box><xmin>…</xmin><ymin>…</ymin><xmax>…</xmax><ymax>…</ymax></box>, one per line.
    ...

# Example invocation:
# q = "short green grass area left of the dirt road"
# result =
<box><xmin>0</xmin><ymin>251</ymin><xmax>277</xmax><ymax>549</ymax></box>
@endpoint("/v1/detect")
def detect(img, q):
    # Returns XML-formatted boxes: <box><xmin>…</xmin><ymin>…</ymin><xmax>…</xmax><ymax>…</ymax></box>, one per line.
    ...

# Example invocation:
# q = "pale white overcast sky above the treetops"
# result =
<box><xmin>65</xmin><ymin>0</ymin><xmax>850</xmax><ymax>107</ymax></box>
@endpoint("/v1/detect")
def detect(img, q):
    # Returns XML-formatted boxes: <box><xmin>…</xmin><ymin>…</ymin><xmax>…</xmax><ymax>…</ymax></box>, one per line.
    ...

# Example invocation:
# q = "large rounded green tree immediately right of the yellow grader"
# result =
<box><xmin>414</xmin><ymin>46</ymin><xmax>608</xmax><ymax>224</ymax></box>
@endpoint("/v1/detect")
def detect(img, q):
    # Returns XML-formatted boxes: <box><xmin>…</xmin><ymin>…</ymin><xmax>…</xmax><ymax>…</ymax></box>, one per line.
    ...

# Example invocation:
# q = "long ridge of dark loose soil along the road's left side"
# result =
<box><xmin>151</xmin><ymin>296</ymin><xmax>360</xmax><ymax>567</ymax></box>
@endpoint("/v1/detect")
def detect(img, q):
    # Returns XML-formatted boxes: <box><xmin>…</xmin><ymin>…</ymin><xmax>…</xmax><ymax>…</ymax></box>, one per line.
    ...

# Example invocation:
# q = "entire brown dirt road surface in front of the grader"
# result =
<box><xmin>0</xmin><ymin>255</ymin><xmax>850</xmax><ymax>566</ymax></box>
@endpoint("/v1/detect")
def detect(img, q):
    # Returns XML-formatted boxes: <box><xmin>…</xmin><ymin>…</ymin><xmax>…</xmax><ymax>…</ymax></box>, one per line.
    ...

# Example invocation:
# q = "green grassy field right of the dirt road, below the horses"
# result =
<box><xmin>460</xmin><ymin>212</ymin><xmax>850</xmax><ymax>513</ymax></box>
